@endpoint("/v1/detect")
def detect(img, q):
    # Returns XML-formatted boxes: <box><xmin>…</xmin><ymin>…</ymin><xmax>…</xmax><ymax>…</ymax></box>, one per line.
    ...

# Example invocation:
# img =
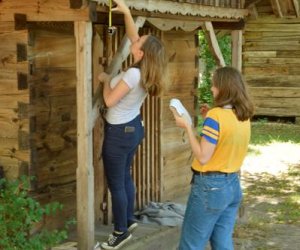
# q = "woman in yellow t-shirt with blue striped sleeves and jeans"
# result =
<box><xmin>175</xmin><ymin>67</ymin><xmax>253</xmax><ymax>250</ymax></box>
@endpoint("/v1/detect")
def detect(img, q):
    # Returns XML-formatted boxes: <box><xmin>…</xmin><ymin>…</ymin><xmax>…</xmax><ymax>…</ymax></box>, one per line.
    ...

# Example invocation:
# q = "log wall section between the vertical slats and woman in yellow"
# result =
<box><xmin>160</xmin><ymin>29</ymin><xmax>198</xmax><ymax>200</ymax></box>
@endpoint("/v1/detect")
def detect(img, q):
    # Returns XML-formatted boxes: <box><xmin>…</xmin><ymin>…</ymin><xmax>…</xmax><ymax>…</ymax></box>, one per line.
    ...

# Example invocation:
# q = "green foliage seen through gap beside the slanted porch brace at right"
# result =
<box><xmin>198</xmin><ymin>31</ymin><xmax>231</xmax><ymax>104</ymax></box>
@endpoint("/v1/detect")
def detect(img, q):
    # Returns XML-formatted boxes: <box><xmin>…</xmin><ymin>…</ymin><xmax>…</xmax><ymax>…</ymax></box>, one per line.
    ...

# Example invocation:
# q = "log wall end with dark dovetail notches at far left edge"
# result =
<box><xmin>0</xmin><ymin>22</ymin><xmax>30</xmax><ymax>179</ymax></box>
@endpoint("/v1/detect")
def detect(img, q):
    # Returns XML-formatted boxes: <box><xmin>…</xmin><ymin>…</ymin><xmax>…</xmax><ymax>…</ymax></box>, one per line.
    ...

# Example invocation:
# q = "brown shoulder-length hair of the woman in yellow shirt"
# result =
<box><xmin>212</xmin><ymin>67</ymin><xmax>254</xmax><ymax>121</ymax></box>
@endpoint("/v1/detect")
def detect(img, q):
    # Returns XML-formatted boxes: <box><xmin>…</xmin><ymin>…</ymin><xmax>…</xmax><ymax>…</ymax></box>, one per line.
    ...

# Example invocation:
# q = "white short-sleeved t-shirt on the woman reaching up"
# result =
<box><xmin>106</xmin><ymin>68</ymin><xmax>147</xmax><ymax>124</ymax></box>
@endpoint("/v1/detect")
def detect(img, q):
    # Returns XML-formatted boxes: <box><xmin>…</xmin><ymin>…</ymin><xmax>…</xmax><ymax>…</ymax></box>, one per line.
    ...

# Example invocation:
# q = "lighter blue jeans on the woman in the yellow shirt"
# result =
<box><xmin>179</xmin><ymin>173</ymin><xmax>242</xmax><ymax>250</ymax></box>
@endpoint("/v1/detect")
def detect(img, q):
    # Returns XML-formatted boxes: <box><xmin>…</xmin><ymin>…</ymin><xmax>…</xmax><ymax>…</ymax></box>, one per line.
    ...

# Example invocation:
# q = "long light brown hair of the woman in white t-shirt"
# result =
<box><xmin>138</xmin><ymin>35</ymin><xmax>167</xmax><ymax>96</ymax></box>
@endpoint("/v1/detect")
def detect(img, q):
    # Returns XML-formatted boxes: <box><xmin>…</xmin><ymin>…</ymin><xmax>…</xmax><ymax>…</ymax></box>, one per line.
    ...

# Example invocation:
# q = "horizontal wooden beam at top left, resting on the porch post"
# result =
<box><xmin>0</xmin><ymin>0</ymin><xmax>89</xmax><ymax>22</ymax></box>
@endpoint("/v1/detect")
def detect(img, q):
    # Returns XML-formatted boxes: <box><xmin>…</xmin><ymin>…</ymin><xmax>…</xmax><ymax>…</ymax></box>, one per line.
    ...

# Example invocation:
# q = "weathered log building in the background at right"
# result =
<box><xmin>243</xmin><ymin>0</ymin><xmax>300</xmax><ymax>123</ymax></box>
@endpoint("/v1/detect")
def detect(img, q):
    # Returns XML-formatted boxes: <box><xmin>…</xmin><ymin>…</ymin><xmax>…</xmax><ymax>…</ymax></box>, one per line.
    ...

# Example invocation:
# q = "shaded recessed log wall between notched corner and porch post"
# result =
<box><xmin>28</xmin><ymin>22</ymin><xmax>77</xmax><ymax>227</ymax></box>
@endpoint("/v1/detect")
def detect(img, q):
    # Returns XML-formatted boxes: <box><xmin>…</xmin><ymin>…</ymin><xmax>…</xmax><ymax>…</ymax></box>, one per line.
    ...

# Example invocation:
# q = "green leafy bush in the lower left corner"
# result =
<box><xmin>0</xmin><ymin>176</ymin><xmax>72</xmax><ymax>250</ymax></box>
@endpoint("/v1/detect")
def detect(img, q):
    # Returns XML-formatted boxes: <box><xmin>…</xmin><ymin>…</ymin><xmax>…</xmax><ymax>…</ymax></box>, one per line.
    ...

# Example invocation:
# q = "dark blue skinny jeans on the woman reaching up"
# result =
<box><xmin>102</xmin><ymin>115</ymin><xmax>144</xmax><ymax>232</ymax></box>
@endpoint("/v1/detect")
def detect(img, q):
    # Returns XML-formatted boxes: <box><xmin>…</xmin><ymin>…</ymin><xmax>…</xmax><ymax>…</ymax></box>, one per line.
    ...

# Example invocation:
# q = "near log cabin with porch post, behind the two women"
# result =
<box><xmin>0</xmin><ymin>0</ymin><xmax>248</xmax><ymax>250</ymax></box>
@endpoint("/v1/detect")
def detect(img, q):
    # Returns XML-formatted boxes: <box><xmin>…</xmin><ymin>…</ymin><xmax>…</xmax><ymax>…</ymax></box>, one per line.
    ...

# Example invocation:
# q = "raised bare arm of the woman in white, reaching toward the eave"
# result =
<box><xmin>112</xmin><ymin>0</ymin><xmax>139</xmax><ymax>43</ymax></box>
